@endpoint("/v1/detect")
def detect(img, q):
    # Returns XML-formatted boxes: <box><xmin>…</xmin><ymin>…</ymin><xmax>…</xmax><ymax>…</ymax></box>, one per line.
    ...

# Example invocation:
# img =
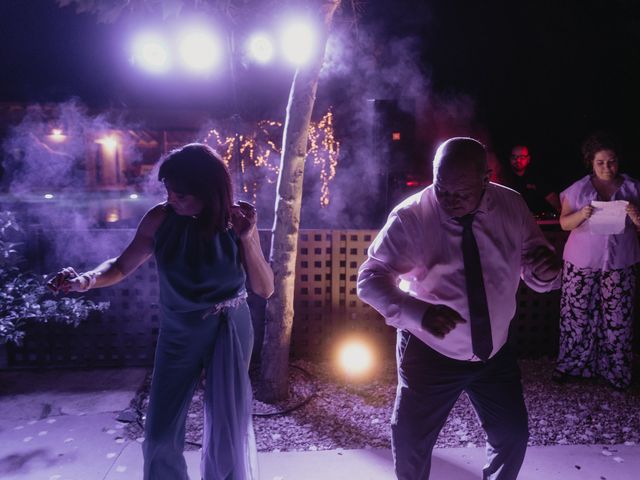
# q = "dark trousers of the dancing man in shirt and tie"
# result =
<box><xmin>391</xmin><ymin>330</ymin><xmax>529</xmax><ymax>480</ymax></box>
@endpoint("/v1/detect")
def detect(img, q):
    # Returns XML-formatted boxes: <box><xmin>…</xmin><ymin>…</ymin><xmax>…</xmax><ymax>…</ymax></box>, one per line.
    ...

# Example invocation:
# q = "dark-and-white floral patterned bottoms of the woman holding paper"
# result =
<box><xmin>556</xmin><ymin>262</ymin><xmax>636</xmax><ymax>388</ymax></box>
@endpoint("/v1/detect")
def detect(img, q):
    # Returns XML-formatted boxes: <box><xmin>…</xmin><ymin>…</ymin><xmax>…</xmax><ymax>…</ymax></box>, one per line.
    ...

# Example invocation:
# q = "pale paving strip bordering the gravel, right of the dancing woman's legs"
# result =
<box><xmin>250</xmin><ymin>445</ymin><xmax>640</xmax><ymax>480</ymax></box>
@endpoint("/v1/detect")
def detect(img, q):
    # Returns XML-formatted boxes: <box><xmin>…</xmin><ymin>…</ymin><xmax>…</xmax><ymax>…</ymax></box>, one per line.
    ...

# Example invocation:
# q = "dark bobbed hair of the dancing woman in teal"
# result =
<box><xmin>158</xmin><ymin>143</ymin><xmax>233</xmax><ymax>234</ymax></box>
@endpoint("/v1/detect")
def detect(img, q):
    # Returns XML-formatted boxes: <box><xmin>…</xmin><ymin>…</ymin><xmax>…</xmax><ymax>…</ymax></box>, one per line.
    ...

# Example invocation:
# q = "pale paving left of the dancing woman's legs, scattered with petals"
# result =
<box><xmin>0</xmin><ymin>369</ymin><xmax>146</xmax><ymax>480</ymax></box>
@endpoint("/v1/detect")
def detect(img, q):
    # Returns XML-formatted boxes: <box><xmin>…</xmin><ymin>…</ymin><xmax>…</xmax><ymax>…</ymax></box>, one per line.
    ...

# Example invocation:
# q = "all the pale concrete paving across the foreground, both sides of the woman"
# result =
<box><xmin>0</xmin><ymin>369</ymin><xmax>640</xmax><ymax>480</ymax></box>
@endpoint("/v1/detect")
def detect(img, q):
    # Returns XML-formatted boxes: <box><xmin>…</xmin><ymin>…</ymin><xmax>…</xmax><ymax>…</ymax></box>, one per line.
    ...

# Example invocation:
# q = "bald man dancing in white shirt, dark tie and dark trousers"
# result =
<box><xmin>358</xmin><ymin>138</ymin><xmax>561</xmax><ymax>480</ymax></box>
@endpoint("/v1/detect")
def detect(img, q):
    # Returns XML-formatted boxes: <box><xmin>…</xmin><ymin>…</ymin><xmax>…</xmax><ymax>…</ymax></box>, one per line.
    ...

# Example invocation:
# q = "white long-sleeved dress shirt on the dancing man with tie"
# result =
<box><xmin>358</xmin><ymin>183</ymin><xmax>560</xmax><ymax>360</ymax></box>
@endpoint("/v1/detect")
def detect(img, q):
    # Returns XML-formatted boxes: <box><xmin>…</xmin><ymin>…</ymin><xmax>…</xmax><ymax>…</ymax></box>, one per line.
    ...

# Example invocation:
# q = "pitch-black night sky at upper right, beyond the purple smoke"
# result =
<box><xmin>362</xmin><ymin>0</ymin><xmax>640</xmax><ymax>182</ymax></box>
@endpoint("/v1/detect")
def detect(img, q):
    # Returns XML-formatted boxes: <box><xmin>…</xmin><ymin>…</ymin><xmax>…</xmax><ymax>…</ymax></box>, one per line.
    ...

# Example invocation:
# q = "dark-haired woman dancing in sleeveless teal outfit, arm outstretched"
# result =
<box><xmin>49</xmin><ymin>144</ymin><xmax>273</xmax><ymax>480</ymax></box>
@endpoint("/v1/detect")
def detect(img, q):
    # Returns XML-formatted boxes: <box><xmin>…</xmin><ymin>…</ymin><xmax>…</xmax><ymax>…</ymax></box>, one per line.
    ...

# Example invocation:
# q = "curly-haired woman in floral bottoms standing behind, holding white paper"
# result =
<box><xmin>553</xmin><ymin>133</ymin><xmax>640</xmax><ymax>389</ymax></box>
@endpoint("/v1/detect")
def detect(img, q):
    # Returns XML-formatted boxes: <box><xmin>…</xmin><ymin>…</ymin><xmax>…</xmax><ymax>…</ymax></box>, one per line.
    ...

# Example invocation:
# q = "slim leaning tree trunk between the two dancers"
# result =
<box><xmin>256</xmin><ymin>0</ymin><xmax>341</xmax><ymax>403</ymax></box>
